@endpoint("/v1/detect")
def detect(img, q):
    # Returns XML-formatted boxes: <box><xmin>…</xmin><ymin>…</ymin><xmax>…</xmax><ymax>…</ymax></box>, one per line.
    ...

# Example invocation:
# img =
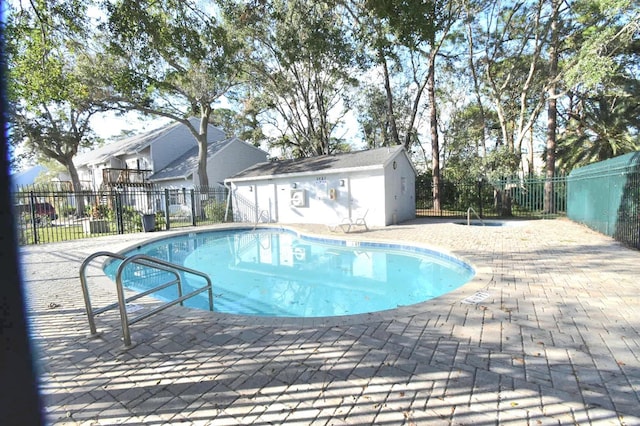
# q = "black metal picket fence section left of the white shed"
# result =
<box><xmin>13</xmin><ymin>186</ymin><xmax>232</xmax><ymax>245</ymax></box>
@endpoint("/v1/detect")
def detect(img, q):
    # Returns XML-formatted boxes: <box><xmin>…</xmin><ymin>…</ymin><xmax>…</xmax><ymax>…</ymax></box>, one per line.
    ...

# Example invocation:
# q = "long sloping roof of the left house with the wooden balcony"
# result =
<box><xmin>74</xmin><ymin>117</ymin><xmax>225</xmax><ymax>166</ymax></box>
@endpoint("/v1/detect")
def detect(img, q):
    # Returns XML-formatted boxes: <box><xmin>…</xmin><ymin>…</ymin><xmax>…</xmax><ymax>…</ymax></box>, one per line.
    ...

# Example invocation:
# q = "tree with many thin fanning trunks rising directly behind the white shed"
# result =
<box><xmin>227</xmin><ymin>0</ymin><xmax>356</xmax><ymax>157</ymax></box>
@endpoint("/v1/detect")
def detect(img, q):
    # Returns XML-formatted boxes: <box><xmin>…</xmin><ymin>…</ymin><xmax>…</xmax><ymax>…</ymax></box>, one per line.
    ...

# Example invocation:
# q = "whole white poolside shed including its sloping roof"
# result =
<box><xmin>225</xmin><ymin>146</ymin><xmax>416</xmax><ymax>226</ymax></box>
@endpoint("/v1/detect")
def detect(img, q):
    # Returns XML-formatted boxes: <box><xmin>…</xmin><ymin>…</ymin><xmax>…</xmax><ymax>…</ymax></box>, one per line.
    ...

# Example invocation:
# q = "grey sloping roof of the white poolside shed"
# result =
<box><xmin>226</xmin><ymin>145</ymin><xmax>406</xmax><ymax>181</ymax></box>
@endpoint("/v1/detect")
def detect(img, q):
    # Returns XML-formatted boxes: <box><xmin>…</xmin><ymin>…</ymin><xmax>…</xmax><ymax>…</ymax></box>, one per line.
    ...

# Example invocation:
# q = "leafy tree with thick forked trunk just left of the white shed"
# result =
<box><xmin>100</xmin><ymin>0</ymin><xmax>242</xmax><ymax>187</ymax></box>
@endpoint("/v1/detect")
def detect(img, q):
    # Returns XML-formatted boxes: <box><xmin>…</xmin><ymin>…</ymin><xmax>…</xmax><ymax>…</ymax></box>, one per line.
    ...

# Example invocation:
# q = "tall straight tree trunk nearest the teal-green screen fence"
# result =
<box><xmin>544</xmin><ymin>0</ymin><xmax>559</xmax><ymax>213</ymax></box>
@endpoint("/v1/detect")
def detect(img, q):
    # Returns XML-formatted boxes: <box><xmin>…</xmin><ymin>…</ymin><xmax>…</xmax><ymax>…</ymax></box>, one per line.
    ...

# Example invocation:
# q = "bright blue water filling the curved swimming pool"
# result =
<box><xmin>105</xmin><ymin>228</ymin><xmax>474</xmax><ymax>317</ymax></box>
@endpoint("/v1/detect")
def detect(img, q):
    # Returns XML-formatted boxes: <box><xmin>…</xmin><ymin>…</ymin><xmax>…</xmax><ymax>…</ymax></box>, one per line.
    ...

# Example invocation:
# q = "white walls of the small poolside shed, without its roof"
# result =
<box><xmin>232</xmin><ymin>148</ymin><xmax>415</xmax><ymax>226</ymax></box>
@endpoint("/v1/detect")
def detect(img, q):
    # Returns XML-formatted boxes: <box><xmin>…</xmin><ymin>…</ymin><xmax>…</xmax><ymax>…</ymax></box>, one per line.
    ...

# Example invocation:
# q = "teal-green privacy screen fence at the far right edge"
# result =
<box><xmin>567</xmin><ymin>152</ymin><xmax>640</xmax><ymax>248</ymax></box>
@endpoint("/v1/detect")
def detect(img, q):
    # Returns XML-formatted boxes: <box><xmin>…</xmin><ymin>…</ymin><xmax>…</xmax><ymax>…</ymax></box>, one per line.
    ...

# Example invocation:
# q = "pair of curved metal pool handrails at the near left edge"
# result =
<box><xmin>80</xmin><ymin>251</ymin><xmax>213</xmax><ymax>347</ymax></box>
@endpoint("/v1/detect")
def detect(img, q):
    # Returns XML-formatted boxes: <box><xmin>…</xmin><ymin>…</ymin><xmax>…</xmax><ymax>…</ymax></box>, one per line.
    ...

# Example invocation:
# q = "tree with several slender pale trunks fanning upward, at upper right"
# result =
<box><xmin>473</xmin><ymin>0</ymin><xmax>562</xmax><ymax>161</ymax></box>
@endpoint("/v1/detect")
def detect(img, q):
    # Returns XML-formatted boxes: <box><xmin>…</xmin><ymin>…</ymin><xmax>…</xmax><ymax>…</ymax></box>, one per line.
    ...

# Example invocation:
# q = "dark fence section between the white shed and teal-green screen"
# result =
<box><xmin>416</xmin><ymin>175</ymin><xmax>567</xmax><ymax>218</ymax></box>
